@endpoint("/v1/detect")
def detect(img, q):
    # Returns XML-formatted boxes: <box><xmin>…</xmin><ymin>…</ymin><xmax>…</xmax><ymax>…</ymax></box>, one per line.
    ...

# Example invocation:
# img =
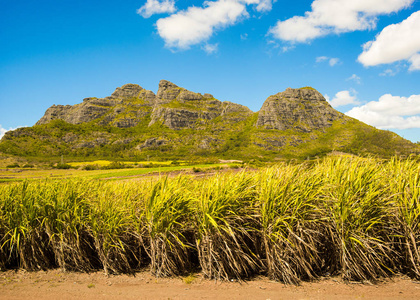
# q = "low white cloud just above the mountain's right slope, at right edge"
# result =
<box><xmin>346</xmin><ymin>94</ymin><xmax>420</xmax><ymax>129</ymax></box>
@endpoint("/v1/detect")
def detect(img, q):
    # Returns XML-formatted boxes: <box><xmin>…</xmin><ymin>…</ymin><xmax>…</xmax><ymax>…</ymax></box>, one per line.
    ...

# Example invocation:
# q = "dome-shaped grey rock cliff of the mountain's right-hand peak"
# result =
<box><xmin>256</xmin><ymin>88</ymin><xmax>348</xmax><ymax>132</ymax></box>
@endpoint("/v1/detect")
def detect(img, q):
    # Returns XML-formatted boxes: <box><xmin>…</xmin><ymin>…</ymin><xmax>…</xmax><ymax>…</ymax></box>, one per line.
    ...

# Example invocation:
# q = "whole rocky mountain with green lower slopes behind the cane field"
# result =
<box><xmin>0</xmin><ymin>80</ymin><xmax>419</xmax><ymax>160</ymax></box>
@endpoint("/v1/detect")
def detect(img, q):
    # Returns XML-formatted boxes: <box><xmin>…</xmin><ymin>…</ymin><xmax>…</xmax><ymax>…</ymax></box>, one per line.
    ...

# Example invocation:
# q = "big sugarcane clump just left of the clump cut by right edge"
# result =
<box><xmin>319</xmin><ymin>159</ymin><xmax>393</xmax><ymax>281</ymax></box>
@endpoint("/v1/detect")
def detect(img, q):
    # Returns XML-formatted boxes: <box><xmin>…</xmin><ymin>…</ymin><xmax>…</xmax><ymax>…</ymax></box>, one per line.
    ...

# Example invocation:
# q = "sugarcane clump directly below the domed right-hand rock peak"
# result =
<box><xmin>257</xmin><ymin>165</ymin><xmax>322</xmax><ymax>284</ymax></box>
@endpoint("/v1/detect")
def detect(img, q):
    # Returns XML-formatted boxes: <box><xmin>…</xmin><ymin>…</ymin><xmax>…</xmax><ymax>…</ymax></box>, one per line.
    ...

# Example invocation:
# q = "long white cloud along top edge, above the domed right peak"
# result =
<box><xmin>269</xmin><ymin>0</ymin><xmax>414</xmax><ymax>42</ymax></box>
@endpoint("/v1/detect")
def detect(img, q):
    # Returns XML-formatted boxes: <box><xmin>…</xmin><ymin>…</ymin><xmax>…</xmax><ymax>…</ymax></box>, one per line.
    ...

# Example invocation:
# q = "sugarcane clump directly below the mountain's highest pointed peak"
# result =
<box><xmin>143</xmin><ymin>177</ymin><xmax>191</xmax><ymax>277</ymax></box>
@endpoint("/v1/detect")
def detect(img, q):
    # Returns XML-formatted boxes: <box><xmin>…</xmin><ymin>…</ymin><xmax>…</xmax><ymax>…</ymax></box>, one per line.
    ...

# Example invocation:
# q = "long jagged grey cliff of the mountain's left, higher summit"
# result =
<box><xmin>36</xmin><ymin>80</ymin><xmax>252</xmax><ymax>129</ymax></box>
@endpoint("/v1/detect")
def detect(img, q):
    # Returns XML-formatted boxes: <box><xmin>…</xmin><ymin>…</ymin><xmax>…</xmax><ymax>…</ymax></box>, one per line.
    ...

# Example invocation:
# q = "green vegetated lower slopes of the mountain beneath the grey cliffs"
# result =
<box><xmin>0</xmin><ymin>114</ymin><xmax>420</xmax><ymax>161</ymax></box>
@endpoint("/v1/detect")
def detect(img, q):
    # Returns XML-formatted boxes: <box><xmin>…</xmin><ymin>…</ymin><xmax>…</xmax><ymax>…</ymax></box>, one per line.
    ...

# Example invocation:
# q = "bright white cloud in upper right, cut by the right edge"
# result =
<box><xmin>358</xmin><ymin>11</ymin><xmax>420</xmax><ymax>70</ymax></box>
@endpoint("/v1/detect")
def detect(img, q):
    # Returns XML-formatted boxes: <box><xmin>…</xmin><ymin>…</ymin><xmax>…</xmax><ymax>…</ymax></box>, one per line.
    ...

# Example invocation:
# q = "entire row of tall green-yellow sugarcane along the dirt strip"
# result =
<box><xmin>0</xmin><ymin>158</ymin><xmax>420</xmax><ymax>283</ymax></box>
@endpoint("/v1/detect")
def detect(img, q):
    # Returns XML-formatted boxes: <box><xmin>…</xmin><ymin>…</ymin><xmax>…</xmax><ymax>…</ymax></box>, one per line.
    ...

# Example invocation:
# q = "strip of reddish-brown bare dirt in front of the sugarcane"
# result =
<box><xmin>0</xmin><ymin>270</ymin><xmax>420</xmax><ymax>300</ymax></box>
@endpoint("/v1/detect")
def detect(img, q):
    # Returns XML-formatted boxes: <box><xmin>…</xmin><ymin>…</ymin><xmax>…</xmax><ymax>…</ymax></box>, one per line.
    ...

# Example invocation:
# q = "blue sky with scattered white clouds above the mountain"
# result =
<box><xmin>0</xmin><ymin>0</ymin><xmax>420</xmax><ymax>142</ymax></box>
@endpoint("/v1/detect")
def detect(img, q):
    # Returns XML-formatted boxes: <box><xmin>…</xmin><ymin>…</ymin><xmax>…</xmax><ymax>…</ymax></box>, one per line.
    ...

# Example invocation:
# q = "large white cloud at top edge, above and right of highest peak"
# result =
<box><xmin>156</xmin><ymin>0</ymin><xmax>273</xmax><ymax>49</ymax></box>
